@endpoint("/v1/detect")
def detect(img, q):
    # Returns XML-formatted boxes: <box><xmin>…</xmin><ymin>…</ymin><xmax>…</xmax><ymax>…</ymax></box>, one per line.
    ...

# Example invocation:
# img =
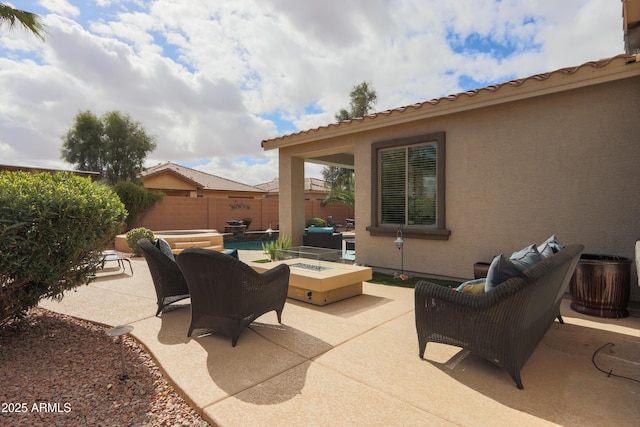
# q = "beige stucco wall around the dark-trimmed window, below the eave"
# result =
<box><xmin>352</xmin><ymin>77</ymin><xmax>640</xmax><ymax>300</ymax></box>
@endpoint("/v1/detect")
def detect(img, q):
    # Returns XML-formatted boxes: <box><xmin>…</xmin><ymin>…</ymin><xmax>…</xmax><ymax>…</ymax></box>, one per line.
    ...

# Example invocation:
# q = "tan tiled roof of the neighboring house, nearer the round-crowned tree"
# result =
<box><xmin>142</xmin><ymin>162</ymin><xmax>264</xmax><ymax>193</ymax></box>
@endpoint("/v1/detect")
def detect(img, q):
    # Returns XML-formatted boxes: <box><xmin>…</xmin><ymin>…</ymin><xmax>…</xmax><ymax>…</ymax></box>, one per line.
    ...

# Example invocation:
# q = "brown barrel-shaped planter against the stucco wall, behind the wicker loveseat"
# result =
<box><xmin>569</xmin><ymin>254</ymin><xmax>631</xmax><ymax>318</ymax></box>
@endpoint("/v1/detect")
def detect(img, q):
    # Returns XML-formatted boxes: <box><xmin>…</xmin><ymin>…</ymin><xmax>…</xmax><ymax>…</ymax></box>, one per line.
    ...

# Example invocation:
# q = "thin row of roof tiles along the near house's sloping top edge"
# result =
<box><xmin>262</xmin><ymin>54</ymin><xmax>638</xmax><ymax>147</ymax></box>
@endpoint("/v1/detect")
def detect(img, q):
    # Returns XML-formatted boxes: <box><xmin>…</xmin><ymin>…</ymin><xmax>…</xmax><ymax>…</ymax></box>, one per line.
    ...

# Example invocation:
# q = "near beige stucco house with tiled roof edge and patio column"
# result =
<box><xmin>262</xmin><ymin>54</ymin><xmax>640</xmax><ymax>299</ymax></box>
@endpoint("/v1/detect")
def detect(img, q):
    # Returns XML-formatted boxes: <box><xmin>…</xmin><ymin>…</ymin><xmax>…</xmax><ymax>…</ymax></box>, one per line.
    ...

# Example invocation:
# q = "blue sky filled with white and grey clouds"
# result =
<box><xmin>0</xmin><ymin>0</ymin><xmax>624</xmax><ymax>184</ymax></box>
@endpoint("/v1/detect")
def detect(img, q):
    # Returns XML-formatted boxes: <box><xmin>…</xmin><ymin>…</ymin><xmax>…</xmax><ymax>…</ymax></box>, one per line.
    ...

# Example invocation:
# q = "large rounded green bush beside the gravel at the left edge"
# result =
<box><xmin>0</xmin><ymin>171</ymin><xmax>127</xmax><ymax>324</ymax></box>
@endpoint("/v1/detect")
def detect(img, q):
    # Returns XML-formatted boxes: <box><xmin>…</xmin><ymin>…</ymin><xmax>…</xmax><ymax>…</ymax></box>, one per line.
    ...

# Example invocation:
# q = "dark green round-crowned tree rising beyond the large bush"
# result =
<box><xmin>61</xmin><ymin>110</ymin><xmax>156</xmax><ymax>184</ymax></box>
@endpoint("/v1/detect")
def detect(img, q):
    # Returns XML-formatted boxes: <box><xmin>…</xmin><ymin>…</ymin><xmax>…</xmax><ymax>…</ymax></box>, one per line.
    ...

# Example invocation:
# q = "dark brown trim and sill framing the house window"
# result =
<box><xmin>366</xmin><ymin>132</ymin><xmax>451</xmax><ymax>240</ymax></box>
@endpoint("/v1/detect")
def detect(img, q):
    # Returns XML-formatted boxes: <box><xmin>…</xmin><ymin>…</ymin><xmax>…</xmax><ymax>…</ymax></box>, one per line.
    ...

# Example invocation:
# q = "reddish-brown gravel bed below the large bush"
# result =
<box><xmin>0</xmin><ymin>308</ymin><xmax>209</xmax><ymax>427</ymax></box>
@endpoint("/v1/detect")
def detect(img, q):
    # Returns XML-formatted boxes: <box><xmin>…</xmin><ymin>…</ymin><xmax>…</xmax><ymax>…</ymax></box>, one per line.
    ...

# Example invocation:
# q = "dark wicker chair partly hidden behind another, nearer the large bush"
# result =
<box><xmin>138</xmin><ymin>239</ymin><xmax>189</xmax><ymax>316</ymax></box>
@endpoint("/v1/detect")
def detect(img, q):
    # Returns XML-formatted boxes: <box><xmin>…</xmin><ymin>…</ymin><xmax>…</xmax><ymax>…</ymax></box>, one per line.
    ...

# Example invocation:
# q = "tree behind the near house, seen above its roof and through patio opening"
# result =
<box><xmin>322</xmin><ymin>82</ymin><xmax>378</xmax><ymax>207</ymax></box>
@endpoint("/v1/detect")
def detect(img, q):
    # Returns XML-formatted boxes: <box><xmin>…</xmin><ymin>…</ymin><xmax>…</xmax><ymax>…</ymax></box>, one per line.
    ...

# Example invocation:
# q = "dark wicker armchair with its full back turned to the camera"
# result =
<box><xmin>176</xmin><ymin>248</ymin><xmax>289</xmax><ymax>347</ymax></box>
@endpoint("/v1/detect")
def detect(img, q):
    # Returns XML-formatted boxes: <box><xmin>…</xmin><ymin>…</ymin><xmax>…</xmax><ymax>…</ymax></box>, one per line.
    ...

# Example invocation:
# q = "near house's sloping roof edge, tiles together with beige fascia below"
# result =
<box><xmin>262</xmin><ymin>54</ymin><xmax>640</xmax><ymax>150</ymax></box>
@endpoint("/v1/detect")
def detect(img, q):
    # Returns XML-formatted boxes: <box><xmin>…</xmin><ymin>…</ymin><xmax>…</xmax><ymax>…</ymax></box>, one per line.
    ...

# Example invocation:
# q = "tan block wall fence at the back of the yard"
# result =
<box><xmin>133</xmin><ymin>196</ymin><xmax>353</xmax><ymax>232</ymax></box>
